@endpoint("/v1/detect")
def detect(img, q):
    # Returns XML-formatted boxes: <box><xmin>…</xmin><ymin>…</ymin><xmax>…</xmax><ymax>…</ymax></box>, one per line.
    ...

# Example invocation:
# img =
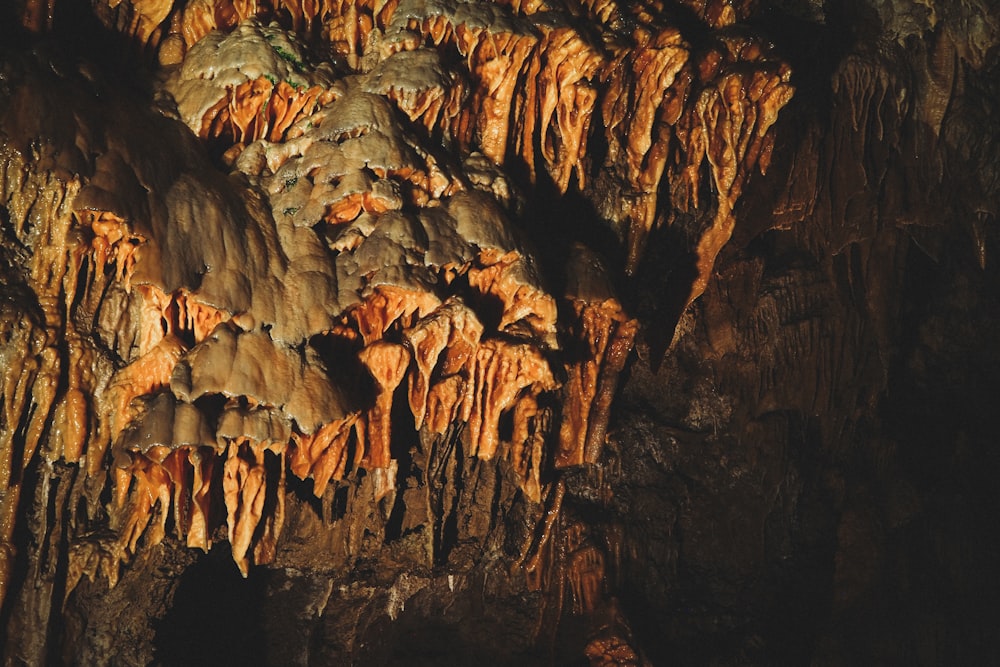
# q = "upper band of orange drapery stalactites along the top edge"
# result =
<box><xmin>82</xmin><ymin>0</ymin><xmax>792</xmax><ymax>290</ymax></box>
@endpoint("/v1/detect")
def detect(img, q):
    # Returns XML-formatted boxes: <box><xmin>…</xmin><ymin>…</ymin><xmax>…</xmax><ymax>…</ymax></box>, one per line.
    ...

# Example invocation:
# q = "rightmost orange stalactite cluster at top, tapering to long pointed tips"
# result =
<box><xmin>591</xmin><ymin>2</ymin><xmax>793</xmax><ymax>286</ymax></box>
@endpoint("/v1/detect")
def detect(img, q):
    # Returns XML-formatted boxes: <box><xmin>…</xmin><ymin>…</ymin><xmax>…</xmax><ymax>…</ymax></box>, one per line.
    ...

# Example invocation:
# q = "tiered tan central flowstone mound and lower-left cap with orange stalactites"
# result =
<box><xmin>100</xmin><ymin>56</ymin><xmax>576</xmax><ymax>573</ymax></box>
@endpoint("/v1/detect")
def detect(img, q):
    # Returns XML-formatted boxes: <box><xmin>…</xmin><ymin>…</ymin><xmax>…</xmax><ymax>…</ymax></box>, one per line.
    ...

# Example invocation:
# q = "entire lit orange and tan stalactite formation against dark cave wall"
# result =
<box><xmin>4</xmin><ymin>0</ymin><xmax>840</xmax><ymax>655</ymax></box>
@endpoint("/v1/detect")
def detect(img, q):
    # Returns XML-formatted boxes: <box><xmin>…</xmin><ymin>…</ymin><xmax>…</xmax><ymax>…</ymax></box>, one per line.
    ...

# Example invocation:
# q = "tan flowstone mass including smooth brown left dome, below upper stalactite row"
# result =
<box><xmin>1</xmin><ymin>23</ymin><xmax>632</xmax><ymax>596</ymax></box>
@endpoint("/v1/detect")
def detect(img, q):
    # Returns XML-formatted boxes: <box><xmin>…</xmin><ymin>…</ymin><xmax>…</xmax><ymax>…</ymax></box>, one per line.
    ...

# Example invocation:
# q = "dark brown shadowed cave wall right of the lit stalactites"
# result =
<box><xmin>617</xmin><ymin>3</ymin><xmax>997</xmax><ymax>664</ymax></box>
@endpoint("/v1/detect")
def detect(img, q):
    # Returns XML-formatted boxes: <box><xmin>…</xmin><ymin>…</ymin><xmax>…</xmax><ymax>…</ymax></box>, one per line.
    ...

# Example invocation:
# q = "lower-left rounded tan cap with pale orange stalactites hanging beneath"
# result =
<box><xmin>99</xmin><ymin>316</ymin><xmax>351</xmax><ymax>574</ymax></box>
